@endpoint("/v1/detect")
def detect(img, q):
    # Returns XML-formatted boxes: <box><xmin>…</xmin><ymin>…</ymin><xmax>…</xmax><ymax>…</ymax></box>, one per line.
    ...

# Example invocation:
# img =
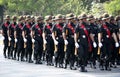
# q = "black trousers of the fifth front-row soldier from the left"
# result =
<box><xmin>34</xmin><ymin>35</ymin><xmax>43</xmax><ymax>61</ymax></box>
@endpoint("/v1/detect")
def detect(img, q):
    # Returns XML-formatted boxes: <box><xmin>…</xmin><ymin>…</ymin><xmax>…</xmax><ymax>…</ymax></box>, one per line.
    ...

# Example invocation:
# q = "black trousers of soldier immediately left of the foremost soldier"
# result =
<box><xmin>65</xmin><ymin>37</ymin><xmax>75</xmax><ymax>67</ymax></box>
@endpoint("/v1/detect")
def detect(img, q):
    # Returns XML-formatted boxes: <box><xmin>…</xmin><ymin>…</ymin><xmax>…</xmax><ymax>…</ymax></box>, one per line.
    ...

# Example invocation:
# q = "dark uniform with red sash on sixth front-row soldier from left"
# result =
<box><xmin>43</xmin><ymin>23</ymin><xmax>54</xmax><ymax>65</ymax></box>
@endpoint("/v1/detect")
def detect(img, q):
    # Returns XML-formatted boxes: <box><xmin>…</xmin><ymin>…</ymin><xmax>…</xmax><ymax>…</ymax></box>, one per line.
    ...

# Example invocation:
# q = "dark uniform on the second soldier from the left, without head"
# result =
<box><xmin>9</xmin><ymin>22</ymin><xmax>17</xmax><ymax>59</ymax></box>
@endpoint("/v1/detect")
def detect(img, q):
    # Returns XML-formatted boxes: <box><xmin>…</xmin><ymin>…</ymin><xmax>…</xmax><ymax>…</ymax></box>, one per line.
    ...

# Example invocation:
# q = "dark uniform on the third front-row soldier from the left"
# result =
<box><xmin>14</xmin><ymin>23</ymin><xmax>25</xmax><ymax>61</ymax></box>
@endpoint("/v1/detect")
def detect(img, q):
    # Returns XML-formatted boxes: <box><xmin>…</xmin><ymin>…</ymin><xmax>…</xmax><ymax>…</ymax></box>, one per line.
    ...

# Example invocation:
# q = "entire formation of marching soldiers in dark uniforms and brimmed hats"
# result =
<box><xmin>2</xmin><ymin>13</ymin><xmax>120</xmax><ymax>72</ymax></box>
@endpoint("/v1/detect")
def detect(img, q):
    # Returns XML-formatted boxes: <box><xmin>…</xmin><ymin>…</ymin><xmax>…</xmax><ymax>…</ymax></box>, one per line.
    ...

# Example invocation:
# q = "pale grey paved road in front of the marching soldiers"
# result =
<box><xmin>0</xmin><ymin>35</ymin><xmax>120</xmax><ymax>77</ymax></box>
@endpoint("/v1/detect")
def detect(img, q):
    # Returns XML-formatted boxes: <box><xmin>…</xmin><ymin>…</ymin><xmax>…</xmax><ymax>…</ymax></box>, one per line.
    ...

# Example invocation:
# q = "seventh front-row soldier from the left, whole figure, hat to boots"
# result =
<box><xmin>52</xmin><ymin>14</ymin><xmax>64</xmax><ymax>68</ymax></box>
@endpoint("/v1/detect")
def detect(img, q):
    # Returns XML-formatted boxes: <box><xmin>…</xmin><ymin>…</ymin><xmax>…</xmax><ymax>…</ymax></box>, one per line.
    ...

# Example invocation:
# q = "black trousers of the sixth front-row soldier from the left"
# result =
<box><xmin>46</xmin><ymin>36</ymin><xmax>54</xmax><ymax>63</ymax></box>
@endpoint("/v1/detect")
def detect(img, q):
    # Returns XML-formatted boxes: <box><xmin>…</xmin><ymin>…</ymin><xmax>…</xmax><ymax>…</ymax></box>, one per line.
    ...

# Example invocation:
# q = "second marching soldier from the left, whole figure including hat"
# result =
<box><xmin>8</xmin><ymin>16</ymin><xmax>17</xmax><ymax>59</ymax></box>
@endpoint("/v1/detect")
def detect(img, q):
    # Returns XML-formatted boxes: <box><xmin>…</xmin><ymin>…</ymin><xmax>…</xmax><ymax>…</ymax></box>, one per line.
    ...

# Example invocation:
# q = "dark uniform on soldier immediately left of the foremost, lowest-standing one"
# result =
<box><xmin>63</xmin><ymin>22</ymin><xmax>75</xmax><ymax>69</ymax></box>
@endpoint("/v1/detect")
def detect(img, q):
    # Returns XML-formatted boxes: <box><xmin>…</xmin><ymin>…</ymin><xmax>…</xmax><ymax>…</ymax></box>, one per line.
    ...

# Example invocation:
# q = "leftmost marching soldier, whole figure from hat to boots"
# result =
<box><xmin>2</xmin><ymin>15</ymin><xmax>10</xmax><ymax>58</ymax></box>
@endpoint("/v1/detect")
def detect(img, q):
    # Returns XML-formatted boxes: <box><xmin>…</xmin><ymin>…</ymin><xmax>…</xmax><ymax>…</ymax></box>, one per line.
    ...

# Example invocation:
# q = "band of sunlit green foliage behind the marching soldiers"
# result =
<box><xmin>0</xmin><ymin>0</ymin><xmax>120</xmax><ymax>16</ymax></box>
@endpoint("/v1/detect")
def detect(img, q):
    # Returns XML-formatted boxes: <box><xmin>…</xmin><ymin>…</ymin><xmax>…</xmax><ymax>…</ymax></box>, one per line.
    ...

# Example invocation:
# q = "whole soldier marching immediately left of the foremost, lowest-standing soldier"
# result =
<box><xmin>63</xmin><ymin>13</ymin><xmax>75</xmax><ymax>70</ymax></box>
